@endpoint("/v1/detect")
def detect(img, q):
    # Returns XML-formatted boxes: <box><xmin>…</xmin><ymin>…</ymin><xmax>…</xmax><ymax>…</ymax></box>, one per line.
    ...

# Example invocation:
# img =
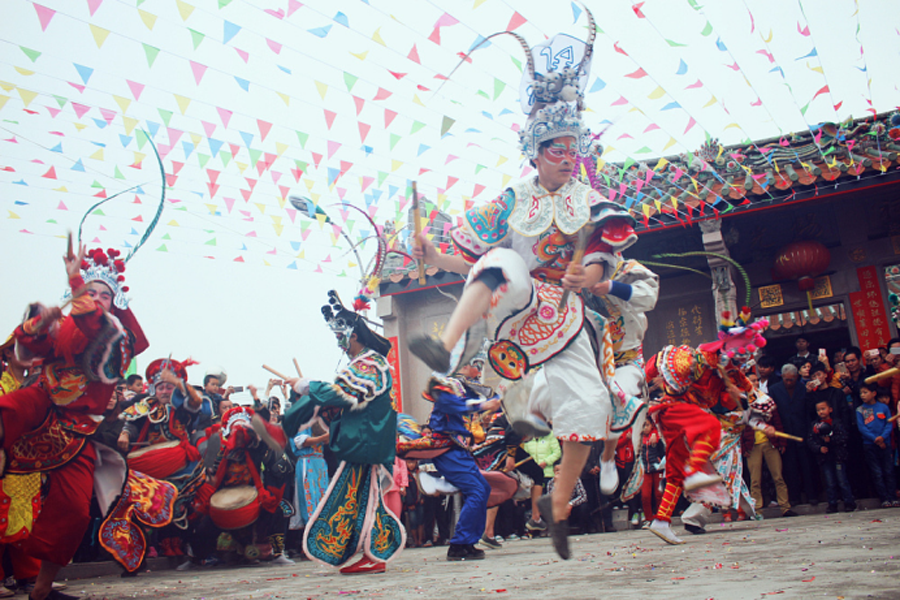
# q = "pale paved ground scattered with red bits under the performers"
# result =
<box><xmin>59</xmin><ymin>509</ymin><xmax>900</xmax><ymax>600</ymax></box>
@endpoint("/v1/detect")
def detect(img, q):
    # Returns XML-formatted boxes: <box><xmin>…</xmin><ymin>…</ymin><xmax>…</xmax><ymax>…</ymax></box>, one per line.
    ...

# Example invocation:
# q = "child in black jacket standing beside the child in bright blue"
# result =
<box><xmin>807</xmin><ymin>398</ymin><xmax>856</xmax><ymax>513</ymax></box>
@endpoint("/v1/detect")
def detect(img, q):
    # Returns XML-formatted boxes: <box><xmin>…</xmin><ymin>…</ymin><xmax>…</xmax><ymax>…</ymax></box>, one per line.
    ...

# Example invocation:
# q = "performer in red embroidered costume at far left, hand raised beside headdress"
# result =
<box><xmin>0</xmin><ymin>247</ymin><xmax>175</xmax><ymax>599</ymax></box>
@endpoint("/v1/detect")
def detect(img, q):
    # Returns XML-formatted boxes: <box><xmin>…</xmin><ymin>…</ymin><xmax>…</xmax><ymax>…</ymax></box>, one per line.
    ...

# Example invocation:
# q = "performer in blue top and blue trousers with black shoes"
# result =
<box><xmin>422</xmin><ymin>357</ymin><xmax>500</xmax><ymax>561</ymax></box>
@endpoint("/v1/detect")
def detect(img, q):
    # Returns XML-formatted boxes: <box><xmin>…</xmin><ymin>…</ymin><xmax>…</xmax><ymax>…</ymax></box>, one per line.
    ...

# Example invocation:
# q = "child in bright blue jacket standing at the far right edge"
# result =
<box><xmin>856</xmin><ymin>383</ymin><xmax>900</xmax><ymax>508</ymax></box>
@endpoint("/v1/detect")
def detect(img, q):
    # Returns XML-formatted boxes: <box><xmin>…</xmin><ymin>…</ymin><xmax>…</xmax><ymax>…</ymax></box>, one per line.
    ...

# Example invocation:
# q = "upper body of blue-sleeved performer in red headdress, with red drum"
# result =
<box><xmin>118</xmin><ymin>358</ymin><xmax>200</xmax><ymax>479</ymax></box>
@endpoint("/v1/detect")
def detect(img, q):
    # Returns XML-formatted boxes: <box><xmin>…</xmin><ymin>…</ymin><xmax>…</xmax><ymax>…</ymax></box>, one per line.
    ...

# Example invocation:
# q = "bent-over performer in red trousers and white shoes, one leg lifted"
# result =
<box><xmin>646</xmin><ymin>346</ymin><xmax>752</xmax><ymax>544</ymax></box>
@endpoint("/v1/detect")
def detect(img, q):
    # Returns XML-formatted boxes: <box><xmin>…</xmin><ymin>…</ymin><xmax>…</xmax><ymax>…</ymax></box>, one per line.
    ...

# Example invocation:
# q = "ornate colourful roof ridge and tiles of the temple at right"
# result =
<box><xmin>582</xmin><ymin>111</ymin><xmax>900</xmax><ymax>231</ymax></box>
